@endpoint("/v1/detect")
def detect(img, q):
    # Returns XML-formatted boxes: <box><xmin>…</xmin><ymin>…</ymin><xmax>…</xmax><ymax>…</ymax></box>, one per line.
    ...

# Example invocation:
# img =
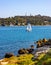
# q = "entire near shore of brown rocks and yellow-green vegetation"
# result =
<box><xmin>0</xmin><ymin>38</ymin><xmax>51</xmax><ymax>65</ymax></box>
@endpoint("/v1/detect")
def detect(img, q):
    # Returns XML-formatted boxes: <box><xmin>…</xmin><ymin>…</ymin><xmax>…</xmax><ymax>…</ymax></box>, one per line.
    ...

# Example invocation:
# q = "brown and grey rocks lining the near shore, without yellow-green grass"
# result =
<box><xmin>0</xmin><ymin>38</ymin><xmax>51</xmax><ymax>65</ymax></box>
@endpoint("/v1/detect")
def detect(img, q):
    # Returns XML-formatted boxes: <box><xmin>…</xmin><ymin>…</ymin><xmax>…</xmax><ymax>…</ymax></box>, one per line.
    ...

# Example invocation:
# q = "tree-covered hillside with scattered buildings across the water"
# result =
<box><xmin>0</xmin><ymin>14</ymin><xmax>51</xmax><ymax>26</ymax></box>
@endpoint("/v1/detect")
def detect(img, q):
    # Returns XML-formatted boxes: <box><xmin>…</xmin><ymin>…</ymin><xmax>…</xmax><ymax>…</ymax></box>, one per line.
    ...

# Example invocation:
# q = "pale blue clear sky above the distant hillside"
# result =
<box><xmin>0</xmin><ymin>0</ymin><xmax>51</xmax><ymax>18</ymax></box>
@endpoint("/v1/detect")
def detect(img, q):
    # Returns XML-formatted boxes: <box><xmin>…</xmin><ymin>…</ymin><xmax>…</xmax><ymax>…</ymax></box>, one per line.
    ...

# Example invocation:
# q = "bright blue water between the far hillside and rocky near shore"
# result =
<box><xmin>0</xmin><ymin>26</ymin><xmax>51</xmax><ymax>58</ymax></box>
